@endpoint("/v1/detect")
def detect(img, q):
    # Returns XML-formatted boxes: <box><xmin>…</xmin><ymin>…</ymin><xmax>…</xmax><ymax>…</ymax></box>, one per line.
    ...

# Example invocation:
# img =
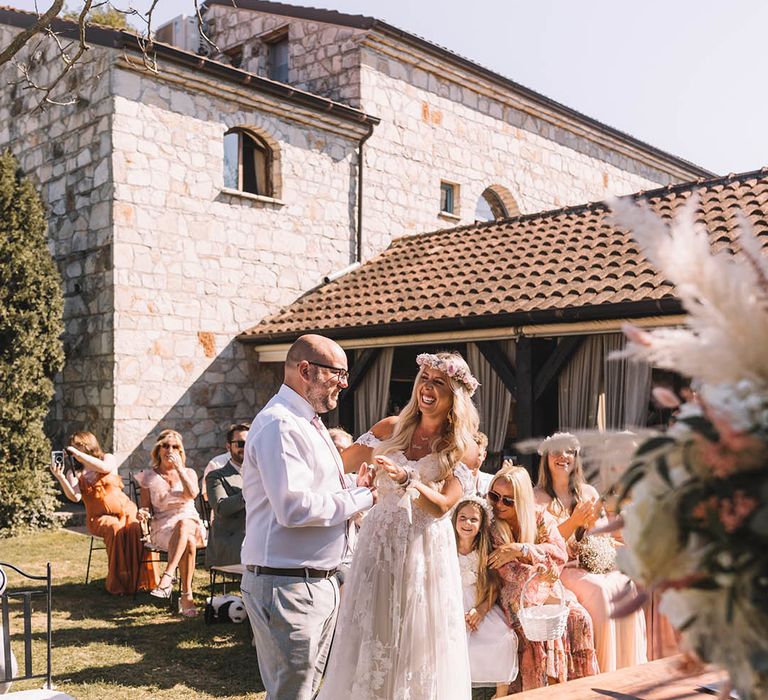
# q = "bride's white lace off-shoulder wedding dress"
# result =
<box><xmin>318</xmin><ymin>433</ymin><xmax>472</xmax><ymax>700</ymax></box>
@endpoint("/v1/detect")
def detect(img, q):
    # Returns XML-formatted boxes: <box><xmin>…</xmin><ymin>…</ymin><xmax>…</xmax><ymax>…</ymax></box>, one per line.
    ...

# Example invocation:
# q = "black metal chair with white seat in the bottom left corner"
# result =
<box><xmin>0</xmin><ymin>562</ymin><xmax>74</xmax><ymax>700</ymax></box>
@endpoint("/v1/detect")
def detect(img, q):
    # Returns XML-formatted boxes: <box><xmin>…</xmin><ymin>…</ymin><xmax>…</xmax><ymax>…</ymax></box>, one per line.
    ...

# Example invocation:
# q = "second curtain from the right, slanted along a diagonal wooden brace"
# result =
<box><xmin>558</xmin><ymin>335</ymin><xmax>605</xmax><ymax>430</ymax></box>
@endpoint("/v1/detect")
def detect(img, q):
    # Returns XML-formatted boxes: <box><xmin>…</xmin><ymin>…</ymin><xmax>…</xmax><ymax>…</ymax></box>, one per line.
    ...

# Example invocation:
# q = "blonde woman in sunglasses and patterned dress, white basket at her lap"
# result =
<box><xmin>487</xmin><ymin>461</ymin><xmax>598</xmax><ymax>691</ymax></box>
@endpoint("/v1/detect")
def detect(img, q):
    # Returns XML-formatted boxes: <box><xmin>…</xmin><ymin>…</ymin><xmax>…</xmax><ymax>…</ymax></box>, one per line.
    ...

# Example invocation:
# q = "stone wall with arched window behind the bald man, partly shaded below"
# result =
<box><xmin>112</xmin><ymin>66</ymin><xmax>368</xmax><ymax>468</ymax></box>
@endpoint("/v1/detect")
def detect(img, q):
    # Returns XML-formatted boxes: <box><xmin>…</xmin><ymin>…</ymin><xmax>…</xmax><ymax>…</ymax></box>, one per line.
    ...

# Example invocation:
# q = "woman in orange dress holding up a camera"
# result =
<box><xmin>51</xmin><ymin>432</ymin><xmax>157</xmax><ymax>595</ymax></box>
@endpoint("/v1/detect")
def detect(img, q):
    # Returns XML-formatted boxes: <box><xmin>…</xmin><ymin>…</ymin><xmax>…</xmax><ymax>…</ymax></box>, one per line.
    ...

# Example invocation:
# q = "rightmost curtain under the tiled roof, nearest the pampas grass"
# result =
<box><xmin>603</xmin><ymin>333</ymin><xmax>651</xmax><ymax>430</ymax></box>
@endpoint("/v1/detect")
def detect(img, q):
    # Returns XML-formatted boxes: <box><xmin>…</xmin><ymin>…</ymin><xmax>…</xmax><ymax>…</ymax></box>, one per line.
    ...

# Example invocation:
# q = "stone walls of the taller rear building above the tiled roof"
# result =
<box><xmin>201</xmin><ymin>5</ymin><xmax>695</xmax><ymax>257</ymax></box>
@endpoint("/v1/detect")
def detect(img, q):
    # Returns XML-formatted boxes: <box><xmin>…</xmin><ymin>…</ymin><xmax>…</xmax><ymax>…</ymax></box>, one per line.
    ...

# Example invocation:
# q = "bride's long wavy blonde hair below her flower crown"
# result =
<box><xmin>376</xmin><ymin>352</ymin><xmax>480</xmax><ymax>481</ymax></box>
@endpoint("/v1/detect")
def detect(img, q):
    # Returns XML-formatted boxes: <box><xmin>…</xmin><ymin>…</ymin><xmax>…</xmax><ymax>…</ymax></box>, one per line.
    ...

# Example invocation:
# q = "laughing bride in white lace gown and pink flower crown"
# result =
<box><xmin>318</xmin><ymin>353</ymin><xmax>478</xmax><ymax>700</ymax></box>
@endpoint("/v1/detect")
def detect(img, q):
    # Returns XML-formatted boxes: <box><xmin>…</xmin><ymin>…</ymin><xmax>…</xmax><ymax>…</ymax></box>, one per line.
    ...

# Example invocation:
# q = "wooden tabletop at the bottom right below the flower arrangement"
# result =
<box><xmin>506</xmin><ymin>656</ymin><xmax>725</xmax><ymax>700</ymax></box>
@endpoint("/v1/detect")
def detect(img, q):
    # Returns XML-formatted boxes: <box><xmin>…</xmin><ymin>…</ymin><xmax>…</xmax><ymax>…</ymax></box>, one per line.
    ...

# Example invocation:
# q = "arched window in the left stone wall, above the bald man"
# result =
<box><xmin>224</xmin><ymin>128</ymin><xmax>273</xmax><ymax>197</ymax></box>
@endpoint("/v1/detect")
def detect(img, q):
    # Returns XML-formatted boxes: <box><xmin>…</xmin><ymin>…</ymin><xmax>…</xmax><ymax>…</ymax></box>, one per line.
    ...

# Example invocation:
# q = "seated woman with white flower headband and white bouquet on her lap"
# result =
<box><xmin>535</xmin><ymin>433</ymin><xmax>647</xmax><ymax>672</ymax></box>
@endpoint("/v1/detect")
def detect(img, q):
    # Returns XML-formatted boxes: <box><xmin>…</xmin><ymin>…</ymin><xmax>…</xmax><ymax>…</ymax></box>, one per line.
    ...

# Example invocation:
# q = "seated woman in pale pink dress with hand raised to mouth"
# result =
<box><xmin>136</xmin><ymin>430</ymin><xmax>206</xmax><ymax>617</ymax></box>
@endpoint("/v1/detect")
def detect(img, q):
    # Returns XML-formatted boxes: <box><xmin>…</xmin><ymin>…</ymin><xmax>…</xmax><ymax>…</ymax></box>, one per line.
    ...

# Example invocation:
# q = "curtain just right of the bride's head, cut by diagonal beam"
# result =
<box><xmin>467</xmin><ymin>340</ymin><xmax>515</xmax><ymax>452</ymax></box>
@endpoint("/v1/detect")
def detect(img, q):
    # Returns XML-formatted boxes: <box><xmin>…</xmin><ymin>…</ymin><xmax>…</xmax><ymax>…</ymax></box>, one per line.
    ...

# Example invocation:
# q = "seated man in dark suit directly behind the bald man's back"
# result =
<box><xmin>205</xmin><ymin>423</ymin><xmax>251</xmax><ymax>569</ymax></box>
